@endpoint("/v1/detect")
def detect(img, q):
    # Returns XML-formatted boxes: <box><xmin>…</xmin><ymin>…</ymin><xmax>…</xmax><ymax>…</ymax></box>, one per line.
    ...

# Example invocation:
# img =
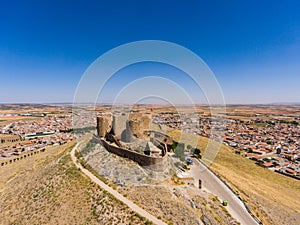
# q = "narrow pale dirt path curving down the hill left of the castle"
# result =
<box><xmin>71</xmin><ymin>143</ymin><xmax>167</xmax><ymax>225</ymax></box>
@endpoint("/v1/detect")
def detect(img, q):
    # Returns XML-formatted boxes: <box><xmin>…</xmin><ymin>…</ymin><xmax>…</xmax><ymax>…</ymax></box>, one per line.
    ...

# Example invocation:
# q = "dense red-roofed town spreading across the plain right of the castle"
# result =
<box><xmin>153</xmin><ymin>113</ymin><xmax>300</xmax><ymax>179</ymax></box>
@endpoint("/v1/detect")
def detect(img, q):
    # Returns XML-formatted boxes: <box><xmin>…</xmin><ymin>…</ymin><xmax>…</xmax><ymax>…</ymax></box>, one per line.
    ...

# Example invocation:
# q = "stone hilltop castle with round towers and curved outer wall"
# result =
<box><xmin>97</xmin><ymin>113</ymin><xmax>173</xmax><ymax>166</ymax></box>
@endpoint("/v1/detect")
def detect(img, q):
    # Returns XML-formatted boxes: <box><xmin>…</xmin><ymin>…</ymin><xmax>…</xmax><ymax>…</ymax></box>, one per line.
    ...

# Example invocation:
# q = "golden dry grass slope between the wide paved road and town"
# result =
<box><xmin>168</xmin><ymin>130</ymin><xmax>300</xmax><ymax>225</ymax></box>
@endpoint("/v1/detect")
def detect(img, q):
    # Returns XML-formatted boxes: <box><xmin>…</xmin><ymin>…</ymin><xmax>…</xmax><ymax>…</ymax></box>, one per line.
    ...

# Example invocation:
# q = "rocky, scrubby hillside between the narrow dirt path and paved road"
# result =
<box><xmin>84</xmin><ymin>144</ymin><xmax>236</xmax><ymax>225</ymax></box>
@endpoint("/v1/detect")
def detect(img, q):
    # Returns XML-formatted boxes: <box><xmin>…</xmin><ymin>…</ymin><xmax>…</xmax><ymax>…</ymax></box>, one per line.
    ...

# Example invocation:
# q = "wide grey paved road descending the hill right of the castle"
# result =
<box><xmin>191</xmin><ymin>159</ymin><xmax>258</xmax><ymax>225</ymax></box>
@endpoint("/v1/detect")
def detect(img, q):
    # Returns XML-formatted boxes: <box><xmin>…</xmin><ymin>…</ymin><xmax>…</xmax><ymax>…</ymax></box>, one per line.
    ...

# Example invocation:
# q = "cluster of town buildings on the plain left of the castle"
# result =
<box><xmin>0</xmin><ymin>116</ymin><xmax>75</xmax><ymax>158</ymax></box>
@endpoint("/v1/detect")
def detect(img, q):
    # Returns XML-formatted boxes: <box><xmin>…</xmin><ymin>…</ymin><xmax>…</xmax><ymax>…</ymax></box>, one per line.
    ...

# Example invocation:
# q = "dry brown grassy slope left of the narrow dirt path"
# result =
<box><xmin>0</xmin><ymin>143</ymin><xmax>148</xmax><ymax>225</ymax></box>
